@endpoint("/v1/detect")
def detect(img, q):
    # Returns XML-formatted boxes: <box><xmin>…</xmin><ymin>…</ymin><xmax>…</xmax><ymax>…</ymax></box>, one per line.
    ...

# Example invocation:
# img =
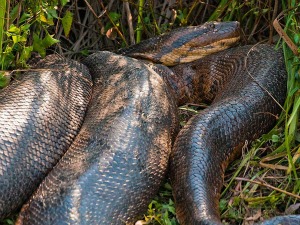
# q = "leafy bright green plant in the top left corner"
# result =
<box><xmin>0</xmin><ymin>0</ymin><xmax>73</xmax><ymax>87</ymax></box>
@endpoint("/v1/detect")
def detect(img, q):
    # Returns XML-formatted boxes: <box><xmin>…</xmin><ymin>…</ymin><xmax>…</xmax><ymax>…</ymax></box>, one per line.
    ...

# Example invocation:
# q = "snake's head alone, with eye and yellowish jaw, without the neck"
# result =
<box><xmin>160</xmin><ymin>22</ymin><xmax>240</xmax><ymax>66</ymax></box>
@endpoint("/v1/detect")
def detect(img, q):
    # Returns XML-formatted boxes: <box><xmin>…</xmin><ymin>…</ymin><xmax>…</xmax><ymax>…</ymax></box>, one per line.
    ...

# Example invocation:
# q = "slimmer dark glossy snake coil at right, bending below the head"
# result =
<box><xmin>170</xmin><ymin>45</ymin><xmax>300</xmax><ymax>225</ymax></box>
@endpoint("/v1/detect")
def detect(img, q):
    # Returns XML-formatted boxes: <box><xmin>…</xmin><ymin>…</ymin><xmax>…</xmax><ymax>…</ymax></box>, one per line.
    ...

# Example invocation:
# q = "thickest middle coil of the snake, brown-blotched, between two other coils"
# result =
<box><xmin>17</xmin><ymin>52</ymin><xmax>178</xmax><ymax>225</ymax></box>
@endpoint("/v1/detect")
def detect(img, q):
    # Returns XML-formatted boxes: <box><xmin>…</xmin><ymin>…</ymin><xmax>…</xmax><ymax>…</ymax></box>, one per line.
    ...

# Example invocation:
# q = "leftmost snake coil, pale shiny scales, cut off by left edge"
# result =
<box><xmin>0</xmin><ymin>55</ymin><xmax>92</xmax><ymax>218</ymax></box>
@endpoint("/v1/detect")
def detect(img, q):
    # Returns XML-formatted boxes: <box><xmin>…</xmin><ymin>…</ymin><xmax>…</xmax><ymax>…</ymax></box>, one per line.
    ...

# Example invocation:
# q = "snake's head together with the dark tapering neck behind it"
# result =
<box><xmin>118</xmin><ymin>21</ymin><xmax>240</xmax><ymax>66</ymax></box>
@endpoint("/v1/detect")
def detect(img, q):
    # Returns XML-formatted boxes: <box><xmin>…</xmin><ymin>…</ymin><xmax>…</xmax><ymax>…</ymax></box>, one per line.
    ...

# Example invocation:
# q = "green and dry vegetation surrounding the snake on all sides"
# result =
<box><xmin>0</xmin><ymin>0</ymin><xmax>300</xmax><ymax>225</ymax></box>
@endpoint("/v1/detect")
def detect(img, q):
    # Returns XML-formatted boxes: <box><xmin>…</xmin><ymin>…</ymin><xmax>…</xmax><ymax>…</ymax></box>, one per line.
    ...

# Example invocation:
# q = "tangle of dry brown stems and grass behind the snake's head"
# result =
<box><xmin>51</xmin><ymin>0</ymin><xmax>282</xmax><ymax>57</ymax></box>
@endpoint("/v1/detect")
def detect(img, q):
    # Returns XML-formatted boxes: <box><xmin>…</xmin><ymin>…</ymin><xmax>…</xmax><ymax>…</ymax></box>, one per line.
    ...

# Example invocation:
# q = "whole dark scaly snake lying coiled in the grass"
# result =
<box><xmin>0</xmin><ymin>22</ymin><xmax>300</xmax><ymax>225</ymax></box>
